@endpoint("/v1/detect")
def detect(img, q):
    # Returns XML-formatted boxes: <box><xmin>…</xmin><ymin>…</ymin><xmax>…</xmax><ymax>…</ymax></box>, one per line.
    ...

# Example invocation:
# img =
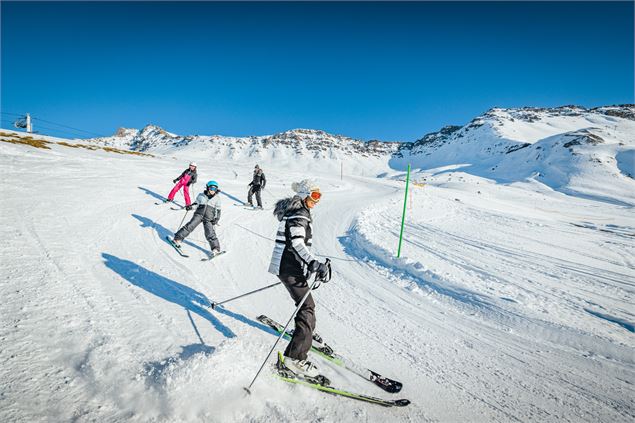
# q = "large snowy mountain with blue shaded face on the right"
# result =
<box><xmin>390</xmin><ymin>105</ymin><xmax>635</xmax><ymax>205</ymax></box>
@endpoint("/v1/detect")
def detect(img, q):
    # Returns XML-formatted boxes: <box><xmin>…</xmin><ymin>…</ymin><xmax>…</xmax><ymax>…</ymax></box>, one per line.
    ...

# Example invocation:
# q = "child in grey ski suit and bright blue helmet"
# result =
<box><xmin>172</xmin><ymin>181</ymin><xmax>221</xmax><ymax>258</ymax></box>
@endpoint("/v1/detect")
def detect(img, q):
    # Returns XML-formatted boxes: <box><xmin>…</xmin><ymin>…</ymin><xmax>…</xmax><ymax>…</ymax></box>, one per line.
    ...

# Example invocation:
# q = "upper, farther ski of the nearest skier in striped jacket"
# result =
<box><xmin>257</xmin><ymin>315</ymin><xmax>403</xmax><ymax>394</ymax></box>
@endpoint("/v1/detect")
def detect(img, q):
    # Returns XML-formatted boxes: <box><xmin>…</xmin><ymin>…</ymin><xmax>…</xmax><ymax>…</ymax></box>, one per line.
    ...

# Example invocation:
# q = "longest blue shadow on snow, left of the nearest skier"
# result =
<box><xmin>101</xmin><ymin>253</ymin><xmax>236</xmax><ymax>338</ymax></box>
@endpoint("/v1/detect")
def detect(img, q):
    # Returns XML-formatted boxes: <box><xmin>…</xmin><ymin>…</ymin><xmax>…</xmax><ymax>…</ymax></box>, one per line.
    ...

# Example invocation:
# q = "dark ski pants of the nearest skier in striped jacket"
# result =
<box><xmin>278</xmin><ymin>275</ymin><xmax>315</xmax><ymax>360</ymax></box>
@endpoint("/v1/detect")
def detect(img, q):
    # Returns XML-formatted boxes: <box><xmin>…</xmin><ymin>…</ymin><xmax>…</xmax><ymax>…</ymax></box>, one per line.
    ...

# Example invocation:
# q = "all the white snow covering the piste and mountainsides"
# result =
<box><xmin>0</xmin><ymin>109</ymin><xmax>635</xmax><ymax>422</ymax></box>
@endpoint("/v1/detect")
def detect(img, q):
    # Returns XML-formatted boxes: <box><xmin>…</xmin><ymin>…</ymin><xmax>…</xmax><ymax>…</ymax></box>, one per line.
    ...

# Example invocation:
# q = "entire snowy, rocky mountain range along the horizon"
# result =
<box><xmin>90</xmin><ymin>105</ymin><xmax>635</xmax><ymax>204</ymax></box>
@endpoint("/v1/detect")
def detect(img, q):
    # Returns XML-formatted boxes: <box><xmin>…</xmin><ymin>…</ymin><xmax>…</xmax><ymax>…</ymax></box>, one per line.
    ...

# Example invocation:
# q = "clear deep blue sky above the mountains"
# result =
<box><xmin>0</xmin><ymin>1</ymin><xmax>634</xmax><ymax>141</ymax></box>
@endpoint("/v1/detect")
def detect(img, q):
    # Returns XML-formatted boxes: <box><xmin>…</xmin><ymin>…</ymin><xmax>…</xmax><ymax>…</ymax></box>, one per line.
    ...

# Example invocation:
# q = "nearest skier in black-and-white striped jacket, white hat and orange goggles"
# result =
<box><xmin>269</xmin><ymin>180</ymin><xmax>328</xmax><ymax>377</ymax></box>
